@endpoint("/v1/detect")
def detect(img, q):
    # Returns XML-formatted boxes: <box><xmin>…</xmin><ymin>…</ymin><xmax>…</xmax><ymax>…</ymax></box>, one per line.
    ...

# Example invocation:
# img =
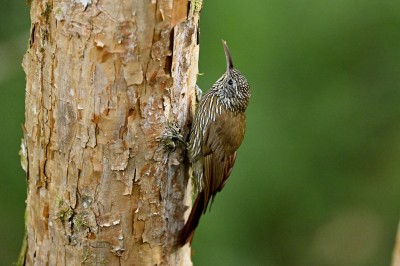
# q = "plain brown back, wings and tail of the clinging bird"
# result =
<box><xmin>179</xmin><ymin>106</ymin><xmax>245</xmax><ymax>246</ymax></box>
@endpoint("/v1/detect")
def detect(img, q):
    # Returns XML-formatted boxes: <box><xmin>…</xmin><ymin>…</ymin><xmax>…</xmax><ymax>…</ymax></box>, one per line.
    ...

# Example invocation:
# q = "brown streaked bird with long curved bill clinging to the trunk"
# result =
<box><xmin>179</xmin><ymin>41</ymin><xmax>251</xmax><ymax>246</ymax></box>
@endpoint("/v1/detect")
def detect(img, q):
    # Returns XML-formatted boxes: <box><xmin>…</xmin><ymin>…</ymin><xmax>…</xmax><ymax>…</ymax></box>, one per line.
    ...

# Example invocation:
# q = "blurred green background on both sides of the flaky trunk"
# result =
<box><xmin>0</xmin><ymin>0</ymin><xmax>400</xmax><ymax>266</ymax></box>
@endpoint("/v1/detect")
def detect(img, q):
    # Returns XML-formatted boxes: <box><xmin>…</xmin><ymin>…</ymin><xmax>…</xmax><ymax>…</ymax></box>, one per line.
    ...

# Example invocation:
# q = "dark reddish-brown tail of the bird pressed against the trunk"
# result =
<box><xmin>179</xmin><ymin>191</ymin><xmax>205</xmax><ymax>246</ymax></box>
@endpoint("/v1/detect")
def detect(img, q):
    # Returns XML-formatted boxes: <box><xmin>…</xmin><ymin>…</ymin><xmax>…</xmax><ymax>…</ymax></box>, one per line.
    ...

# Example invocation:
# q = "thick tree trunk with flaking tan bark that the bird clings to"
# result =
<box><xmin>22</xmin><ymin>0</ymin><xmax>201</xmax><ymax>265</ymax></box>
